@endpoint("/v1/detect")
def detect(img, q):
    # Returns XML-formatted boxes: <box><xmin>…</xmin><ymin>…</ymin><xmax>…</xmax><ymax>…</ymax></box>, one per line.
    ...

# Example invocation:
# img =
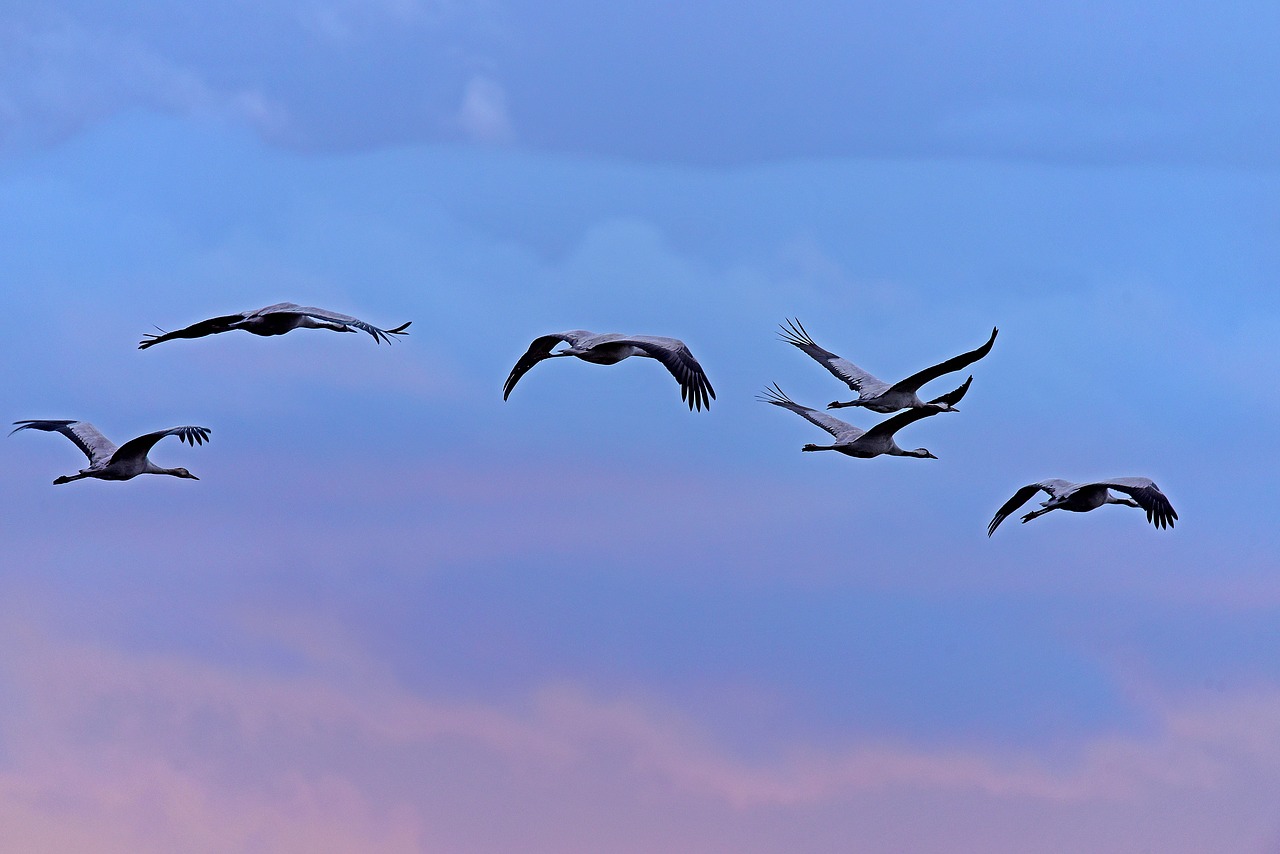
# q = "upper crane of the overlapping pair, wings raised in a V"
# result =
<box><xmin>781</xmin><ymin>319</ymin><xmax>1000</xmax><ymax>414</ymax></box>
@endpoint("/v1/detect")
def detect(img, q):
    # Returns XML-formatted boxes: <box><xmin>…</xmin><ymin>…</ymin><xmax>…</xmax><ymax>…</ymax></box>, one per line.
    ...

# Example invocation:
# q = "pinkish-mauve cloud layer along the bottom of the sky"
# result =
<box><xmin>0</xmin><ymin>606</ymin><xmax>1280</xmax><ymax>854</ymax></box>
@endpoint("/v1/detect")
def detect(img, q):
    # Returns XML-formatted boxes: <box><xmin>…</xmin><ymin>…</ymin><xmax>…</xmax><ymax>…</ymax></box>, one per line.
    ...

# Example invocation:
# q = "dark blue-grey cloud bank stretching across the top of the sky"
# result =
<box><xmin>0</xmin><ymin>0</ymin><xmax>1280</xmax><ymax>168</ymax></box>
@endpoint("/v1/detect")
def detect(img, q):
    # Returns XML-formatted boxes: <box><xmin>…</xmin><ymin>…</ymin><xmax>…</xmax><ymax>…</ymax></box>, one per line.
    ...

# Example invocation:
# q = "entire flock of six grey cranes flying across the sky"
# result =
<box><xmin>10</xmin><ymin>302</ymin><xmax>1178</xmax><ymax>536</ymax></box>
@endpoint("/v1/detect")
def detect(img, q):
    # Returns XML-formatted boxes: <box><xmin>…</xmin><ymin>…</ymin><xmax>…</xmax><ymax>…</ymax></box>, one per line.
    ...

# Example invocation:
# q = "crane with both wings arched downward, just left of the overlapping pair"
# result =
<box><xmin>502</xmin><ymin>329</ymin><xmax>716</xmax><ymax>411</ymax></box>
